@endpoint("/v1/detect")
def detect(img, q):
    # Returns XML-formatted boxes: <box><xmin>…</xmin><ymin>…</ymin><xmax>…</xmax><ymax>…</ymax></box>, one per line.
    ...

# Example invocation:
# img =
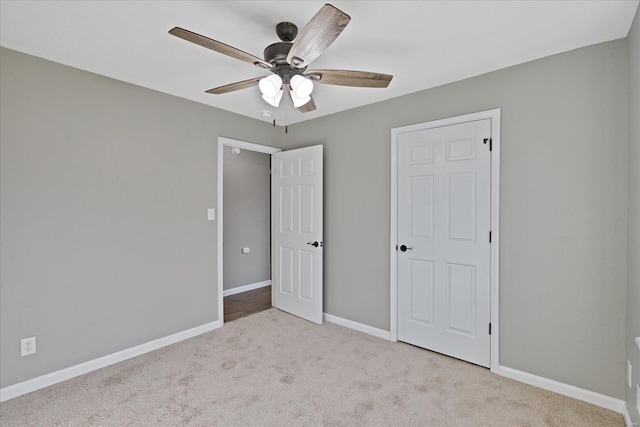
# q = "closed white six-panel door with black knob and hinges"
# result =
<box><xmin>397</xmin><ymin>119</ymin><xmax>491</xmax><ymax>367</ymax></box>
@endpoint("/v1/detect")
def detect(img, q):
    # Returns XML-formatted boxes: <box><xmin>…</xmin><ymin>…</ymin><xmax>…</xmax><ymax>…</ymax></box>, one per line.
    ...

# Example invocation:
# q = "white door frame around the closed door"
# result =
<box><xmin>389</xmin><ymin>108</ymin><xmax>500</xmax><ymax>374</ymax></box>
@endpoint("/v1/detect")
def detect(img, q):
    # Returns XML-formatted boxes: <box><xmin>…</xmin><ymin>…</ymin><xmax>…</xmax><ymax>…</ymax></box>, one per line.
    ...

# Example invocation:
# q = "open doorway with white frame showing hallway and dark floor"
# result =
<box><xmin>218</xmin><ymin>137</ymin><xmax>281</xmax><ymax>323</ymax></box>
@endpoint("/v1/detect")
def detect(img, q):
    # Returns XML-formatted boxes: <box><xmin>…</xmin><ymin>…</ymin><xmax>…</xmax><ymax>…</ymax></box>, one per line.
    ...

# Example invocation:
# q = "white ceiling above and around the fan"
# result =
<box><xmin>0</xmin><ymin>0</ymin><xmax>638</xmax><ymax>124</ymax></box>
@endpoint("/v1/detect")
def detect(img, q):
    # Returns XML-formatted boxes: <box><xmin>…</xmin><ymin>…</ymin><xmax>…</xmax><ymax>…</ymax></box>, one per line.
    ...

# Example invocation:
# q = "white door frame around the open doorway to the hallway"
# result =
<box><xmin>217</xmin><ymin>136</ymin><xmax>282</xmax><ymax>326</ymax></box>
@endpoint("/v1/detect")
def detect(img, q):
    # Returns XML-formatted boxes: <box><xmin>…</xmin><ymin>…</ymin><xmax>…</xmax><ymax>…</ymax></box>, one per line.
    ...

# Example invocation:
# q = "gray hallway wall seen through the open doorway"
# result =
<box><xmin>222</xmin><ymin>146</ymin><xmax>271</xmax><ymax>290</ymax></box>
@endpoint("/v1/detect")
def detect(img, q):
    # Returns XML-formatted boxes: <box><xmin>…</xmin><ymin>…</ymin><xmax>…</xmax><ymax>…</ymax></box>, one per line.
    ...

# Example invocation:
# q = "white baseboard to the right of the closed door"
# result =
<box><xmin>498</xmin><ymin>366</ymin><xmax>626</xmax><ymax>414</ymax></box>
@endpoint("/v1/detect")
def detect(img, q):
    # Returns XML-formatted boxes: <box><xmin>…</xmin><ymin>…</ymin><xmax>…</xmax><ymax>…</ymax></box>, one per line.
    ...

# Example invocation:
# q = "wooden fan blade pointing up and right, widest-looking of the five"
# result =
<box><xmin>287</xmin><ymin>4</ymin><xmax>351</xmax><ymax>68</ymax></box>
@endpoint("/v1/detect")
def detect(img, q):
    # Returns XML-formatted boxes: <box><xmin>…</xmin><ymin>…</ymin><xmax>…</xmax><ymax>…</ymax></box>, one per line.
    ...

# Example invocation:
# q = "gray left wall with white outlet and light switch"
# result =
<box><xmin>0</xmin><ymin>49</ymin><xmax>273</xmax><ymax>386</ymax></box>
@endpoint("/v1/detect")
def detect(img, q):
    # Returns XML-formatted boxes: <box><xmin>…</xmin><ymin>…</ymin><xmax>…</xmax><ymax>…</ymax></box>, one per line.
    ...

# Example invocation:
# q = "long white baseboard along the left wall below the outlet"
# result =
<box><xmin>0</xmin><ymin>320</ymin><xmax>222</xmax><ymax>402</ymax></box>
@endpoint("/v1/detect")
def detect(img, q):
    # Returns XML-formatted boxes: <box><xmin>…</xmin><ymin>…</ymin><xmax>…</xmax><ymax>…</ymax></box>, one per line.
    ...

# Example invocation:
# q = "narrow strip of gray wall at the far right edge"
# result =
<box><xmin>625</xmin><ymin>12</ymin><xmax>640</xmax><ymax>425</ymax></box>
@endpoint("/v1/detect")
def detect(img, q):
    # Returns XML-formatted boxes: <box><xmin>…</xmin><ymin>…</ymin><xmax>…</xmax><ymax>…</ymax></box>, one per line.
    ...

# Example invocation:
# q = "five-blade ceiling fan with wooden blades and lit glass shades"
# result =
<box><xmin>169</xmin><ymin>4</ymin><xmax>393</xmax><ymax>113</ymax></box>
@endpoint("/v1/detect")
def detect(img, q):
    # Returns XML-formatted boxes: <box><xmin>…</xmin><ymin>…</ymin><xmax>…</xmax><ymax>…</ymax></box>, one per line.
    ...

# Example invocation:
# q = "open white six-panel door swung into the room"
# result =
<box><xmin>271</xmin><ymin>145</ymin><xmax>323</xmax><ymax>323</ymax></box>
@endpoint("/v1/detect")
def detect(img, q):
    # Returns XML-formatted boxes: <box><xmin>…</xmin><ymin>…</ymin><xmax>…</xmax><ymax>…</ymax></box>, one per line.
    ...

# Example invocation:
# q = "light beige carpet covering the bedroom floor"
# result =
<box><xmin>0</xmin><ymin>309</ymin><xmax>624</xmax><ymax>427</ymax></box>
